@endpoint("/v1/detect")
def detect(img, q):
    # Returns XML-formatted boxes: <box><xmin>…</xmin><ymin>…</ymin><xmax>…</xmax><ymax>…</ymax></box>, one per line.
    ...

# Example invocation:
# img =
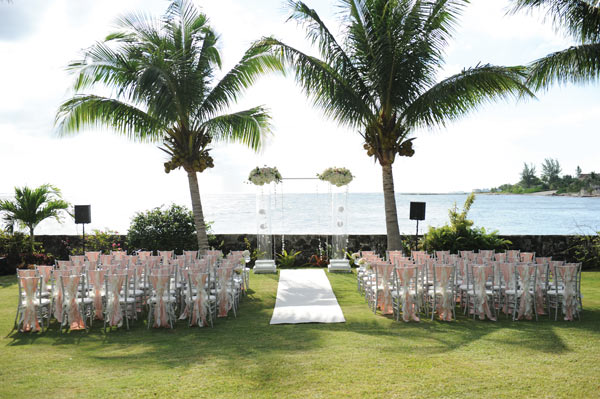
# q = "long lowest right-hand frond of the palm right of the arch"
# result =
<box><xmin>399</xmin><ymin>64</ymin><xmax>534</xmax><ymax>127</ymax></box>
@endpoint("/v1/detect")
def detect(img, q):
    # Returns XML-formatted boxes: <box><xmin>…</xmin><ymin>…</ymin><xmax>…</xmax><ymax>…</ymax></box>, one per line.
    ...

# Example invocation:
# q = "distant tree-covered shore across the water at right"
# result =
<box><xmin>486</xmin><ymin>158</ymin><xmax>600</xmax><ymax>197</ymax></box>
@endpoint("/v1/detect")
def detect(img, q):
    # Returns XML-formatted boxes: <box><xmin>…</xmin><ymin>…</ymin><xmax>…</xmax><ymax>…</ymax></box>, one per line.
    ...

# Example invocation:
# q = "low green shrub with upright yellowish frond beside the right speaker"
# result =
<box><xmin>421</xmin><ymin>193</ymin><xmax>512</xmax><ymax>253</ymax></box>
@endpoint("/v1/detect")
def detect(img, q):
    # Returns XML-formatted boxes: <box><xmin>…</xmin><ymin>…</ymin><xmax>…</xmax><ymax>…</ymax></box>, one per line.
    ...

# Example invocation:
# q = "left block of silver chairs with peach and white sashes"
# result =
<box><xmin>14</xmin><ymin>251</ymin><xmax>249</xmax><ymax>331</ymax></box>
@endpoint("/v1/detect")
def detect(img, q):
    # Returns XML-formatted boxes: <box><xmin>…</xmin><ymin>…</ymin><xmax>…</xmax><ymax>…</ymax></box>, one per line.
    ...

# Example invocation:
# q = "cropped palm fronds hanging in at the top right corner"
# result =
<box><xmin>512</xmin><ymin>0</ymin><xmax>600</xmax><ymax>90</ymax></box>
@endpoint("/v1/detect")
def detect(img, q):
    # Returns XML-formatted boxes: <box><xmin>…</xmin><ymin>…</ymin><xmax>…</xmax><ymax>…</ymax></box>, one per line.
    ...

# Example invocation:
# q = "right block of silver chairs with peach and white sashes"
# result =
<box><xmin>357</xmin><ymin>251</ymin><xmax>583</xmax><ymax>321</ymax></box>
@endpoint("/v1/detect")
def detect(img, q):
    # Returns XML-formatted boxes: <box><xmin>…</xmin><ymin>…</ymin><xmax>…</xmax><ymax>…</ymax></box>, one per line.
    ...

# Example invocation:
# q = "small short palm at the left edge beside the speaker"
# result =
<box><xmin>0</xmin><ymin>184</ymin><xmax>70</xmax><ymax>250</ymax></box>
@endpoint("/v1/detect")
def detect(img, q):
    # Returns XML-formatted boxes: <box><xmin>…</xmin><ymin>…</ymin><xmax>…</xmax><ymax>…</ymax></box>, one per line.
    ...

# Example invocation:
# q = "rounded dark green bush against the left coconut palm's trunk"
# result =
<box><xmin>127</xmin><ymin>204</ymin><xmax>198</xmax><ymax>253</ymax></box>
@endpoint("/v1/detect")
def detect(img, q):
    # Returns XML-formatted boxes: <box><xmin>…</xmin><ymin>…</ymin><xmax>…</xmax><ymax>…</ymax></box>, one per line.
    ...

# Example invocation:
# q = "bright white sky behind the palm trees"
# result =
<box><xmin>0</xmin><ymin>0</ymin><xmax>600</xmax><ymax>233</ymax></box>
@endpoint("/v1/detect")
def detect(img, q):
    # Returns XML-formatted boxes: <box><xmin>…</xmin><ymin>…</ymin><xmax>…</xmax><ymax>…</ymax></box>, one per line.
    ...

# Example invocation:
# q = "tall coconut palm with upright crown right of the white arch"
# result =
<box><xmin>262</xmin><ymin>0</ymin><xmax>531</xmax><ymax>250</ymax></box>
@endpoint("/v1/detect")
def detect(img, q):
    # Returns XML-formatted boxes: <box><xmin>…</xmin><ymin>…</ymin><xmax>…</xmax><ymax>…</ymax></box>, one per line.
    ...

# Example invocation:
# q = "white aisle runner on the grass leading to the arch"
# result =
<box><xmin>271</xmin><ymin>269</ymin><xmax>346</xmax><ymax>324</ymax></box>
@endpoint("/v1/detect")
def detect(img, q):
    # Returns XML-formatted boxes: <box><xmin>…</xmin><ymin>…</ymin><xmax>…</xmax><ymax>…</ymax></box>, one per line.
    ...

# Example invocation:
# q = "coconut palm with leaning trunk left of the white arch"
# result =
<box><xmin>57</xmin><ymin>0</ymin><xmax>282</xmax><ymax>249</ymax></box>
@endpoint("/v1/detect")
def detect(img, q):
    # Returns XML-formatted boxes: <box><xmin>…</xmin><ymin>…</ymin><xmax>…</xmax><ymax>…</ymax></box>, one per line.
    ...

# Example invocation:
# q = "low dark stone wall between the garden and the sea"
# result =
<box><xmin>36</xmin><ymin>234</ymin><xmax>577</xmax><ymax>265</ymax></box>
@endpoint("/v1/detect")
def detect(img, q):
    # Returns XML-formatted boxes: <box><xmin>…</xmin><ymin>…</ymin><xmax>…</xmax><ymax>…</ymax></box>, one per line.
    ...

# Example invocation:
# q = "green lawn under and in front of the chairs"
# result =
<box><xmin>0</xmin><ymin>272</ymin><xmax>600</xmax><ymax>399</ymax></box>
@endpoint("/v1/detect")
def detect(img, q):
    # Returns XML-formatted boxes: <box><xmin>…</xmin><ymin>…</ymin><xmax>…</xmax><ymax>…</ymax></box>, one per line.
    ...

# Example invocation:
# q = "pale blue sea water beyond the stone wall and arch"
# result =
<box><xmin>203</xmin><ymin>193</ymin><xmax>600</xmax><ymax>235</ymax></box>
